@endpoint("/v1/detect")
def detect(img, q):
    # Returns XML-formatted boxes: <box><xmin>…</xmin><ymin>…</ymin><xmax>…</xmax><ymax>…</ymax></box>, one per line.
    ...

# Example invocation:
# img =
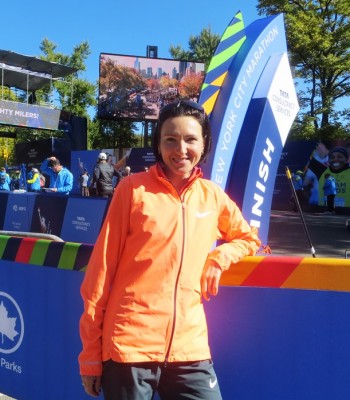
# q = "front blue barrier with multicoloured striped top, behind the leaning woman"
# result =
<box><xmin>0</xmin><ymin>236</ymin><xmax>350</xmax><ymax>400</ymax></box>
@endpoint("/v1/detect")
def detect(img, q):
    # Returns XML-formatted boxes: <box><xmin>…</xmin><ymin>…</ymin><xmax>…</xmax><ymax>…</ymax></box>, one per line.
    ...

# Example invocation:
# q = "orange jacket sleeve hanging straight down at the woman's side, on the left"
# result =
<box><xmin>79</xmin><ymin>180</ymin><xmax>131</xmax><ymax>376</ymax></box>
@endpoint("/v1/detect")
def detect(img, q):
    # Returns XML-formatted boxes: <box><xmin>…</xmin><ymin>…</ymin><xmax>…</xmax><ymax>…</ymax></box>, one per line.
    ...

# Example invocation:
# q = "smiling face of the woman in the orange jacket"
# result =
<box><xmin>159</xmin><ymin>116</ymin><xmax>204</xmax><ymax>180</ymax></box>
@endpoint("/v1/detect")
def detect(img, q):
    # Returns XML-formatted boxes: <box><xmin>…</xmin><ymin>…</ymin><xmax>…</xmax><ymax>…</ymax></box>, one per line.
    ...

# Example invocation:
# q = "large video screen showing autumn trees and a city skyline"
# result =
<box><xmin>98</xmin><ymin>53</ymin><xmax>204</xmax><ymax>121</ymax></box>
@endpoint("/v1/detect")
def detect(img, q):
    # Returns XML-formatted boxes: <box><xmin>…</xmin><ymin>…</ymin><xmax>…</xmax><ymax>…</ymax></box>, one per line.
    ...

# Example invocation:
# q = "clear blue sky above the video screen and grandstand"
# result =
<box><xmin>0</xmin><ymin>0</ymin><xmax>260</xmax><ymax>87</ymax></box>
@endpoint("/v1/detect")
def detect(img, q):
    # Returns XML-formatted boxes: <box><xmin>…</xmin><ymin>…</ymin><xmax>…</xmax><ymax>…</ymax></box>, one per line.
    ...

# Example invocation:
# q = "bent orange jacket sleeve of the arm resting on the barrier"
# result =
<box><xmin>206</xmin><ymin>188</ymin><xmax>261</xmax><ymax>271</ymax></box>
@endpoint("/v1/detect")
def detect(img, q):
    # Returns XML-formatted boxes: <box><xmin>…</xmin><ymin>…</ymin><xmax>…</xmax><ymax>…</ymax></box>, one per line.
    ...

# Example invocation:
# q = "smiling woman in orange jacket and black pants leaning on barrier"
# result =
<box><xmin>79</xmin><ymin>100</ymin><xmax>260</xmax><ymax>400</ymax></box>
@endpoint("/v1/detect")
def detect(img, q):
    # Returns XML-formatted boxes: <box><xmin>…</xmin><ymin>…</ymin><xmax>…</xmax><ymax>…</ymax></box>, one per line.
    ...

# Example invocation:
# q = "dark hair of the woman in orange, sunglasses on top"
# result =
<box><xmin>152</xmin><ymin>100</ymin><xmax>211</xmax><ymax>162</ymax></box>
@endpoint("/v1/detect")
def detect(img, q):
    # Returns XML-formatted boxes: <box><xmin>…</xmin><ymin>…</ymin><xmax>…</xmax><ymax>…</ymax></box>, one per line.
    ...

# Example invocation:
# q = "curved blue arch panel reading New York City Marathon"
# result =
<box><xmin>203</xmin><ymin>14</ymin><xmax>286</xmax><ymax>189</ymax></box>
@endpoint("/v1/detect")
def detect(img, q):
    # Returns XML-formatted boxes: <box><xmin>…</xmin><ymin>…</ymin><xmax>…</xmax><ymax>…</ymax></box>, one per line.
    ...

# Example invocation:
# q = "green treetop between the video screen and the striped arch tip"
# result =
<box><xmin>169</xmin><ymin>26</ymin><xmax>220</xmax><ymax>68</ymax></box>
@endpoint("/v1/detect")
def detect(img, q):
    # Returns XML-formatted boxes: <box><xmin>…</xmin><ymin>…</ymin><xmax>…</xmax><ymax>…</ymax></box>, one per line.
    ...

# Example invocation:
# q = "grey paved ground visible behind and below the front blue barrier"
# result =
<box><xmin>0</xmin><ymin>211</ymin><xmax>350</xmax><ymax>400</ymax></box>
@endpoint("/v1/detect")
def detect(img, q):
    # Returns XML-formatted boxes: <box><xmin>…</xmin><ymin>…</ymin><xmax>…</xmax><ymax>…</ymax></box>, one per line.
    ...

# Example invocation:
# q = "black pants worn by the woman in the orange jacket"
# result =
<box><xmin>102</xmin><ymin>360</ymin><xmax>222</xmax><ymax>400</ymax></box>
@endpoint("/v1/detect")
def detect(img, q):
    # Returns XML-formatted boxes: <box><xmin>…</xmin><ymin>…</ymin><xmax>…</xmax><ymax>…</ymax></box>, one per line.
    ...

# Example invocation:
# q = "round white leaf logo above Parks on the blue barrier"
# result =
<box><xmin>0</xmin><ymin>292</ymin><xmax>24</xmax><ymax>354</ymax></box>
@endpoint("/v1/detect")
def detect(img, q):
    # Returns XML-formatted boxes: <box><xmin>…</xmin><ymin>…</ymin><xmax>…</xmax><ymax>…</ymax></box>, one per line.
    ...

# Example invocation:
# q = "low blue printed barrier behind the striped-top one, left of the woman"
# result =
<box><xmin>0</xmin><ymin>192</ymin><xmax>109</xmax><ymax>244</ymax></box>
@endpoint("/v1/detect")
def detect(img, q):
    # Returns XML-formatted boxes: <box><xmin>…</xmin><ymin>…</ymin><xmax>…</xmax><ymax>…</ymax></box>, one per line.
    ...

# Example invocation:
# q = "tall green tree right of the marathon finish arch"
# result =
<box><xmin>257</xmin><ymin>0</ymin><xmax>350</xmax><ymax>138</ymax></box>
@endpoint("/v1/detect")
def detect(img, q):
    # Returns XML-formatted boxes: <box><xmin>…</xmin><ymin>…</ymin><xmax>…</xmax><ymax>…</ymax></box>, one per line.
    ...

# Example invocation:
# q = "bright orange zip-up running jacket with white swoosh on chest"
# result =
<box><xmin>79</xmin><ymin>165</ymin><xmax>260</xmax><ymax>375</ymax></box>
